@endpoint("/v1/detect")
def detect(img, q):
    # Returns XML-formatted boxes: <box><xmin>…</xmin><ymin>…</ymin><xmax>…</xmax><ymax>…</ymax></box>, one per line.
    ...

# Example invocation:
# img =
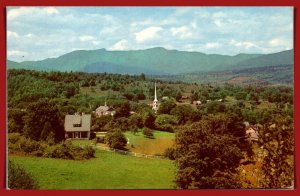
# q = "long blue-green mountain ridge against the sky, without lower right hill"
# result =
<box><xmin>8</xmin><ymin>47</ymin><xmax>293</xmax><ymax>74</ymax></box>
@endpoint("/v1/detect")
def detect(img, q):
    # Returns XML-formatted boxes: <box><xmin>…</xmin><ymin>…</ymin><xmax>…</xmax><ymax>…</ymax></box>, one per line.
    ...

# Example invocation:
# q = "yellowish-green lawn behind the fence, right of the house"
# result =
<box><xmin>125</xmin><ymin>131</ymin><xmax>175</xmax><ymax>155</ymax></box>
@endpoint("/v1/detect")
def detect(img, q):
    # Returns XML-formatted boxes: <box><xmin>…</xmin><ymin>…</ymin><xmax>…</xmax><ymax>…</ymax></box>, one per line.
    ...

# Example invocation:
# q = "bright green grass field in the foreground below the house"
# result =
<box><xmin>9</xmin><ymin>150</ymin><xmax>175</xmax><ymax>189</ymax></box>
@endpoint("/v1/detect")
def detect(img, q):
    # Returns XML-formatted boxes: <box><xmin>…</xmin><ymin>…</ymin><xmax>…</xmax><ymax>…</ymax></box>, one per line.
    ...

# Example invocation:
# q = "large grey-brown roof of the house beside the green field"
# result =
<box><xmin>65</xmin><ymin>114</ymin><xmax>91</xmax><ymax>132</ymax></box>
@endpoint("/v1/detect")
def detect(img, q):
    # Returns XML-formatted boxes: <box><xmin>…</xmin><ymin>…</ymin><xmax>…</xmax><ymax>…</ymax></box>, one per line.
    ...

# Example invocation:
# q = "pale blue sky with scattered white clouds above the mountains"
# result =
<box><xmin>7</xmin><ymin>7</ymin><xmax>293</xmax><ymax>62</ymax></box>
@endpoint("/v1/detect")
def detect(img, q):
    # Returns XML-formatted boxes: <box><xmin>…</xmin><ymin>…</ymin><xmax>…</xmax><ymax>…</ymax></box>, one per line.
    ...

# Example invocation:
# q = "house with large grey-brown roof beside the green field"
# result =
<box><xmin>65</xmin><ymin>114</ymin><xmax>91</xmax><ymax>139</ymax></box>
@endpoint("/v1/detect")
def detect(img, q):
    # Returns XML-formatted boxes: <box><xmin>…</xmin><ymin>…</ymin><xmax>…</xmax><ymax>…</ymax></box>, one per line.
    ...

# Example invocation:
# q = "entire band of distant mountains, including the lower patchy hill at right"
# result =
<box><xmin>7</xmin><ymin>47</ymin><xmax>294</xmax><ymax>84</ymax></box>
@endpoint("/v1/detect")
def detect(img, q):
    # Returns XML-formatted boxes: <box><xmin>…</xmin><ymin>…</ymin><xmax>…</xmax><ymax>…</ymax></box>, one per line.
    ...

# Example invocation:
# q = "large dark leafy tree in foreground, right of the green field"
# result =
<box><xmin>175</xmin><ymin>120</ymin><xmax>243</xmax><ymax>189</ymax></box>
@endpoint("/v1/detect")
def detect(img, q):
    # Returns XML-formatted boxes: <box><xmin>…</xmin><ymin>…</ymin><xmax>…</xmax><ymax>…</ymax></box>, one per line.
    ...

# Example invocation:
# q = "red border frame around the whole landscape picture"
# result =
<box><xmin>0</xmin><ymin>0</ymin><xmax>300</xmax><ymax>196</ymax></box>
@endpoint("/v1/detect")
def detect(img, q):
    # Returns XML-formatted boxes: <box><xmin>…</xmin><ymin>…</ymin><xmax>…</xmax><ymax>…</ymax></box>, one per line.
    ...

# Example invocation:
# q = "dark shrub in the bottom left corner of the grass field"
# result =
<box><xmin>8</xmin><ymin>161</ymin><xmax>38</xmax><ymax>189</ymax></box>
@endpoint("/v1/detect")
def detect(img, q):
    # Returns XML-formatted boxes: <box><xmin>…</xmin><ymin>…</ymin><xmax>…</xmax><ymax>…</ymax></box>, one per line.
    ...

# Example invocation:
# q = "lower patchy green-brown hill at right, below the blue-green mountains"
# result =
<box><xmin>152</xmin><ymin>64</ymin><xmax>294</xmax><ymax>86</ymax></box>
